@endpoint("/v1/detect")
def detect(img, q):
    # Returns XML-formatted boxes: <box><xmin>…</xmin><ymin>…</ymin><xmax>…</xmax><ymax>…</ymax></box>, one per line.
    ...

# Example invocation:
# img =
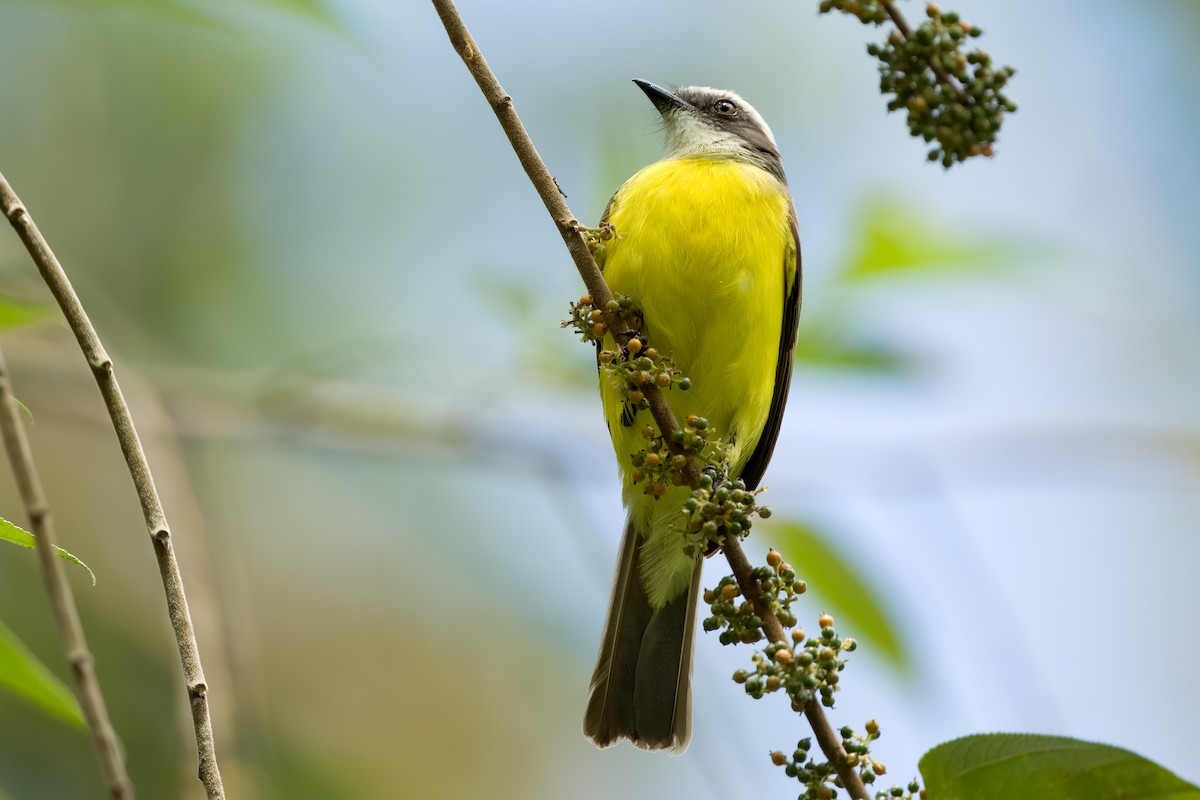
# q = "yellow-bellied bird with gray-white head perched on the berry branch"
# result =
<box><xmin>583</xmin><ymin>80</ymin><xmax>802</xmax><ymax>754</ymax></box>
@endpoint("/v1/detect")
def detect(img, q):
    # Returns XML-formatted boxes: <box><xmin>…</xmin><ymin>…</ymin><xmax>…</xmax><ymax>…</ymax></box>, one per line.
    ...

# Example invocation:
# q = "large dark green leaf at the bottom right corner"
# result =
<box><xmin>920</xmin><ymin>733</ymin><xmax>1200</xmax><ymax>800</ymax></box>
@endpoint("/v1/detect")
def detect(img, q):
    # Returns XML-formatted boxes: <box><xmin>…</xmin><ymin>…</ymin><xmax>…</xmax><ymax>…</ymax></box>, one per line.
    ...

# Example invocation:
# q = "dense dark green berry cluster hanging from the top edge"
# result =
<box><xmin>821</xmin><ymin>0</ymin><xmax>1016</xmax><ymax>168</ymax></box>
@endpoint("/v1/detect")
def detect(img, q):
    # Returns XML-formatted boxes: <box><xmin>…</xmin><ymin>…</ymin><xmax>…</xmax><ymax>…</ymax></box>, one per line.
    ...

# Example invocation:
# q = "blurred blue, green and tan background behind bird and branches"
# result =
<box><xmin>0</xmin><ymin>0</ymin><xmax>1200</xmax><ymax>800</ymax></box>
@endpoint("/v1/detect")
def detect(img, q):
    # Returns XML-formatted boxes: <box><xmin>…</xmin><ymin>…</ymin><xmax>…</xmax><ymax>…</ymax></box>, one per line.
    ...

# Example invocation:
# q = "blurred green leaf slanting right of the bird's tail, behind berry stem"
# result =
<box><xmin>755</xmin><ymin>517</ymin><xmax>911</xmax><ymax>672</ymax></box>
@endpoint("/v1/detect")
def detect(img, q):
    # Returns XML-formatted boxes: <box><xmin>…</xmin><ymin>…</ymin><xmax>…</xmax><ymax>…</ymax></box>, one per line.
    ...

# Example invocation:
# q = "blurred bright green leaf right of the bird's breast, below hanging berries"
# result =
<box><xmin>841</xmin><ymin>199</ymin><xmax>1028</xmax><ymax>283</ymax></box>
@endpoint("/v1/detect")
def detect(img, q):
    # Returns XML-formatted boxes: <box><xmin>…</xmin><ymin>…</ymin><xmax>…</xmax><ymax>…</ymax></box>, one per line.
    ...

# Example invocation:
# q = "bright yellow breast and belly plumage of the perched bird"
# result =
<box><xmin>601</xmin><ymin>157</ymin><xmax>794</xmax><ymax>607</ymax></box>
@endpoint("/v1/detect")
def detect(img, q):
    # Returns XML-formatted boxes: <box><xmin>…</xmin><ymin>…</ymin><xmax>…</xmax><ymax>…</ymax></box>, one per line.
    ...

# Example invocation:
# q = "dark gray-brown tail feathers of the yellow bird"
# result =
<box><xmin>583</xmin><ymin>521</ymin><xmax>701</xmax><ymax>754</ymax></box>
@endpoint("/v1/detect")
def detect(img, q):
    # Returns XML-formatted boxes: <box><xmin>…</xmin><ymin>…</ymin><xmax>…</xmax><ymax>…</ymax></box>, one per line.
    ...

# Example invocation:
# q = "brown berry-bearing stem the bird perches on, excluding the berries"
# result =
<box><xmin>433</xmin><ymin>0</ymin><xmax>868</xmax><ymax>800</ymax></box>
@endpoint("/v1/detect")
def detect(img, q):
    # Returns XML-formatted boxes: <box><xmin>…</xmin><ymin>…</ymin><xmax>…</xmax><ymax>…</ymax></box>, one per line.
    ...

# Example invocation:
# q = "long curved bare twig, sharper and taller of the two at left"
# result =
<box><xmin>0</xmin><ymin>174</ymin><xmax>224</xmax><ymax>800</ymax></box>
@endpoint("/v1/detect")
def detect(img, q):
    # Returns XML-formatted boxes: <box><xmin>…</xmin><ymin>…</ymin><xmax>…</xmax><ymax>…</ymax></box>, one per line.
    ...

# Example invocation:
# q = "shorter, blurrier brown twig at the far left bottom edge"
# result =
<box><xmin>0</xmin><ymin>353</ymin><xmax>133</xmax><ymax>800</ymax></box>
